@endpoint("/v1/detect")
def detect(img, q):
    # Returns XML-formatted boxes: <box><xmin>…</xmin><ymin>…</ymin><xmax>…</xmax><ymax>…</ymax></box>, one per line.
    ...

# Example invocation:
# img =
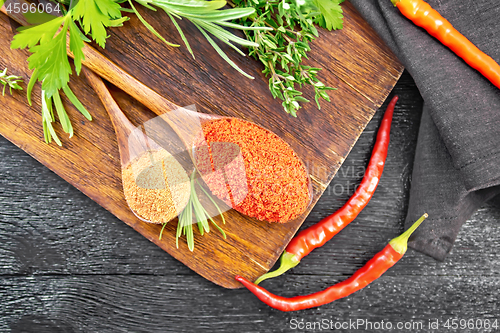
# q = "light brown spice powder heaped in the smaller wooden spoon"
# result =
<box><xmin>122</xmin><ymin>149</ymin><xmax>191</xmax><ymax>223</ymax></box>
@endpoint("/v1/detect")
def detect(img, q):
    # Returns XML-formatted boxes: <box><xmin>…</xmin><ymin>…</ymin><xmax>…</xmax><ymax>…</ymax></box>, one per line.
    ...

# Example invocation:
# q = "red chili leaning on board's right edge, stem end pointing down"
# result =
<box><xmin>255</xmin><ymin>96</ymin><xmax>398</xmax><ymax>284</ymax></box>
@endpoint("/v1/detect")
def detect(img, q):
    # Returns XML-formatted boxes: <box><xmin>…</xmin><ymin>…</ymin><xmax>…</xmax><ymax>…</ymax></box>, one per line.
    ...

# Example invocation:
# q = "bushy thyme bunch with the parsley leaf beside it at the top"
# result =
<box><xmin>232</xmin><ymin>0</ymin><xmax>343</xmax><ymax>117</ymax></box>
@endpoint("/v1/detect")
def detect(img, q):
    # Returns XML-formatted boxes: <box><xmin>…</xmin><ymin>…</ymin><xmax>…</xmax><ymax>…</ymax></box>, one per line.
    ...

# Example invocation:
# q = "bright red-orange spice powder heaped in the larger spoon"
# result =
<box><xmin>195</xmin><ymin>118</ymin><xmax>311</xmax><ymax>223</ymax></box>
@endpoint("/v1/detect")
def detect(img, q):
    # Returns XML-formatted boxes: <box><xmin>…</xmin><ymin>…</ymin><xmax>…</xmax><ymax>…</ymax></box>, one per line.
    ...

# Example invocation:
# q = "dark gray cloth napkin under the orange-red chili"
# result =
<box><xmin>351</xmin><ymin>0</ymin><xmax>500</xmax><ymax>260</ymax></box>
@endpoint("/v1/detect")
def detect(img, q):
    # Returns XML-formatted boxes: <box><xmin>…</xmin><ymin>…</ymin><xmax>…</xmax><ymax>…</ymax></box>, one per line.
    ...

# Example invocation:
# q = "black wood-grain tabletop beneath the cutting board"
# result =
<box><xmin>0</xmin><ymin>72</ymin><xmax>500</xmax><ymax>332</ymax></box>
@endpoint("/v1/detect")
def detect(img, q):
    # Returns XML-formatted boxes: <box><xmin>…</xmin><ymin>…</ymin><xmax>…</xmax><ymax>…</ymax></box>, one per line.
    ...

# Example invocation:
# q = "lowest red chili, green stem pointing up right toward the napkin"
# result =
<box><xmin>236</xmin><ymin>214</ymin><xmax>427</xmax><ymax>311</ymax></box>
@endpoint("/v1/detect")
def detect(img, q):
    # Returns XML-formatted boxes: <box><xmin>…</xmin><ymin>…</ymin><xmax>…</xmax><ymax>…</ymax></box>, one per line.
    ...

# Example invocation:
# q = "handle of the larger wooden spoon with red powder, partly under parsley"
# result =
<box><xmin>0</xmin><ymin>0</ymin><xmax>179</xmax><ymax>115</ymax></box>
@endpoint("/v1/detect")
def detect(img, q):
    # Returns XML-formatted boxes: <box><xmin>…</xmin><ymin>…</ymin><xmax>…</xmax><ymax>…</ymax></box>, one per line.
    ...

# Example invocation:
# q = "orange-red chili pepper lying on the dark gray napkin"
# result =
<box><xmin>391</xmin><ymin>0</ymin><xmax>500</xmax><ymax>88</ymax></box>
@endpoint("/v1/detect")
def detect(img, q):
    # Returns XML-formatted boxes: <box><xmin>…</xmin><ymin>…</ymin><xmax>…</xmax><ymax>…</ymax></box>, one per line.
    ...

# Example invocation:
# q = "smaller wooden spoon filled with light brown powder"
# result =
<box><xmin>82</xmin><ymin>67</ymin><xmax>191</xmax><ymax>224</ymax></box>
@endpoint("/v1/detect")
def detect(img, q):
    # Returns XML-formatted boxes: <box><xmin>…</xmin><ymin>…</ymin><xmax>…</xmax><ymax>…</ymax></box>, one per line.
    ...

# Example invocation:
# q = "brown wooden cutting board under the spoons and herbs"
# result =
<box><xmin>0</xmin><ymin>2</ymin><xmax>403</xmax><ymax>288</ymax></box>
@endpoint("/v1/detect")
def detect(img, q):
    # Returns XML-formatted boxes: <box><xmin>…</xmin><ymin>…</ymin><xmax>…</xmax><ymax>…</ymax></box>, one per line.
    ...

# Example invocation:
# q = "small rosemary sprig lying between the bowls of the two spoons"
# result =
<box><xmin>159</xmin><ymin>171</ymin><xmax>226</xmax><ymax>251</ymax></box>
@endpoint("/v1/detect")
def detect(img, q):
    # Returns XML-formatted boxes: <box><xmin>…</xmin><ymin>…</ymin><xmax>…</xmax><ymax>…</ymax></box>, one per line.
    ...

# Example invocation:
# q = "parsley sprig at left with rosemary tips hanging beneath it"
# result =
<box><xmin>11</xmin><ymin>0</ymin><xmax>124</xmax><ymax>145</ymax></box>
